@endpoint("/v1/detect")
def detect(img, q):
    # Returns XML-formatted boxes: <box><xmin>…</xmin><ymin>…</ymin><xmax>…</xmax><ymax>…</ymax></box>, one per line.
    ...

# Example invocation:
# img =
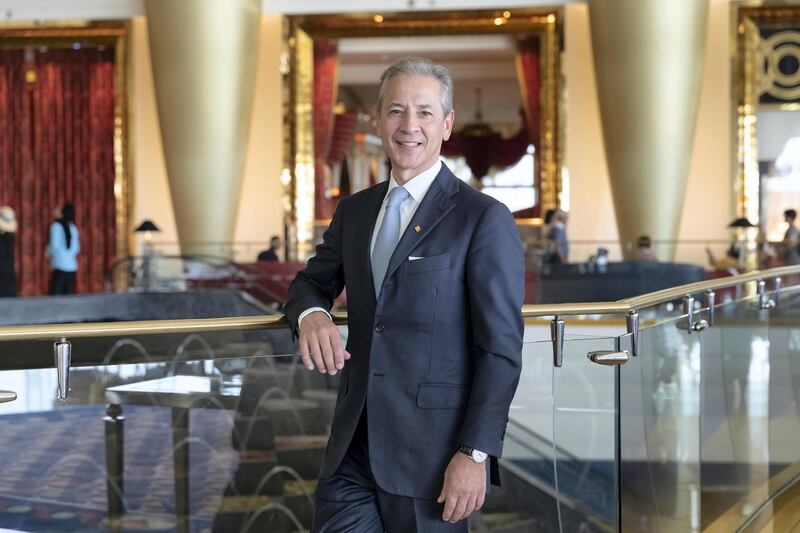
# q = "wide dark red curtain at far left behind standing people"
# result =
<box><xmin>0</xmin><ymin>47</ymin><xmax>116</xmax><ymax>295</ymax></box>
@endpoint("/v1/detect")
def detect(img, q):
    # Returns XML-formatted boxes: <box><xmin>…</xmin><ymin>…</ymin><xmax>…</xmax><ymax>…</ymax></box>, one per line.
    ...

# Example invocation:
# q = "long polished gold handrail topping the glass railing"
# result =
<box><xmin>0</xmin><ymin>266</ymin><xmax>800</xmax><ymax>341</ymax></box>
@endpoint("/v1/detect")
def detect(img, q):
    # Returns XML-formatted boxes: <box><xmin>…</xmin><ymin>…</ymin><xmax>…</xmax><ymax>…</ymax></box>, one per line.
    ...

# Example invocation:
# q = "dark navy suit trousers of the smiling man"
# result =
<box><xmin>311</xmin><ymin>410</ymin><xmax>468</xmax><ymax>533</ymax></box>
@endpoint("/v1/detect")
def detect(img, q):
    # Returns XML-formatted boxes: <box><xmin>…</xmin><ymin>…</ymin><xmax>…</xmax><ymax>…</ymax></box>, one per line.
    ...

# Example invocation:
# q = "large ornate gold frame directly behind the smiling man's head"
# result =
<box><xmin>282</xmin><ymin>8</ymin><xmax>563</xmax><ymax>259</ymax></box>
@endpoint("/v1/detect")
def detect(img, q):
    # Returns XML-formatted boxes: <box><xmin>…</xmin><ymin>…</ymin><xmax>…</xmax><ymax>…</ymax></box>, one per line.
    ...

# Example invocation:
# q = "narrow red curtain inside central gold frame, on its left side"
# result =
<box><xmin>311</xmin><ymin>39</ymin><xmax>338</xmax><ymax>220</ymax></box>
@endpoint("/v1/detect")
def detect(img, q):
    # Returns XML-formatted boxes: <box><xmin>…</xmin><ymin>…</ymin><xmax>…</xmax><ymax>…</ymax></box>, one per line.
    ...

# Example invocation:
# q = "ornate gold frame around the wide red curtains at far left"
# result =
<box><xmin>0</xmin><ymin>22</ymin><xmax>133</xmax><ymax>289</ymax></box>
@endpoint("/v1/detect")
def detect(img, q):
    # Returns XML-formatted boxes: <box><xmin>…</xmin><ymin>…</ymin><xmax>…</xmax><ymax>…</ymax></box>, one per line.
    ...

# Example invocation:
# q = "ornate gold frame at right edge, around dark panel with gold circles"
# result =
<box><xmin>733</xmin><ymin>2</ymin><xmax>800</xmax><ymax>223</ymax></box>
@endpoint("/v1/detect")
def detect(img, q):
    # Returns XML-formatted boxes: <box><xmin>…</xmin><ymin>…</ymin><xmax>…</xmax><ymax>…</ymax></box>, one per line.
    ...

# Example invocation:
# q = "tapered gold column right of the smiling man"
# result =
<box><xmin>589</xmin><ymin>0</ymin><xmax>714</xmax><ymax>260</ymax></box>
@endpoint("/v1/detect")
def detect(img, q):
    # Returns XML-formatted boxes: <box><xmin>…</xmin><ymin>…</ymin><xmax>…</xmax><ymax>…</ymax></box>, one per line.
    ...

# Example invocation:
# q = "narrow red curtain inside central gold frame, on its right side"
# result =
<box><xmin>517</xmin><ymin>36</ymin><xmax>542</xmax><ymax>217</ymax></box>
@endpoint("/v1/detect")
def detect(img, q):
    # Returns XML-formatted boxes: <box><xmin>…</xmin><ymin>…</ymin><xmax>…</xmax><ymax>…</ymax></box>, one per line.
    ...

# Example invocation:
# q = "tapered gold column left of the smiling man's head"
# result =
<box><xmin>142</xmin><ymin>0</ymin><xmax>258</xmax><ymax>254</ymax></box>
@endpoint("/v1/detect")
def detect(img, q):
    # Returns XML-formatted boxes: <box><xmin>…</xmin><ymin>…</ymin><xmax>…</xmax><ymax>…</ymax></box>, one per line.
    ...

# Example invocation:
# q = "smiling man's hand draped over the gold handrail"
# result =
<box><xmin>300</xmin><ymin>311</ymin><xmax>350</xmax><ymax>376</ymax></box>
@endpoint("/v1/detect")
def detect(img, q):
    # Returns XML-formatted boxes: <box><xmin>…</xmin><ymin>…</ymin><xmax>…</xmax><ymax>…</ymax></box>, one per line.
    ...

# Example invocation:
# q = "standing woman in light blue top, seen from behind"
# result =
<box><xmin>50</xmin><ymin>203</ymin><xmax>81</xmax><ymax>294</ymax></box>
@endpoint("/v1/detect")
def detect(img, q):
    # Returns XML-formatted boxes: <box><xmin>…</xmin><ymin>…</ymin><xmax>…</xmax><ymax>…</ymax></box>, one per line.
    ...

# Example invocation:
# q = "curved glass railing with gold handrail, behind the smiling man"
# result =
<box><xmin>0</xmin><ymin>267</ymin><xmax>800</xmax><ymax>532</ymax></box>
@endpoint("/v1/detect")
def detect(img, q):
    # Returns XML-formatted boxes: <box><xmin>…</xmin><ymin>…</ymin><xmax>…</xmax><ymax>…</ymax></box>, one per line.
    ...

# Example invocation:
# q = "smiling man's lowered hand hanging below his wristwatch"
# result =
<box><xmin>436</xmin><ymin>452</ymin><xmax>489</xmax><ymax>524</ymax></box>
